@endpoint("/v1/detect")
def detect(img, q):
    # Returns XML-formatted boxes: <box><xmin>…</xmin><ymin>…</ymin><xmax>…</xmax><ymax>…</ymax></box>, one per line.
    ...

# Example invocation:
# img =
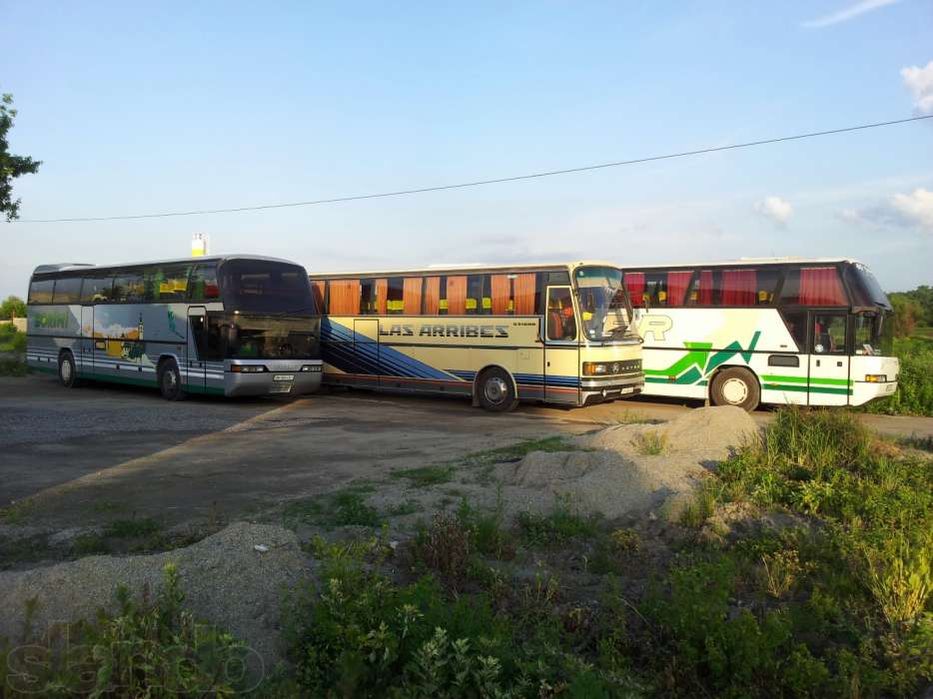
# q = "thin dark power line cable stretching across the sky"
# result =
<box><xmin>13</xmin><ymin>114</ymin><xmax>933</xmax><ymax>223</ymax></box>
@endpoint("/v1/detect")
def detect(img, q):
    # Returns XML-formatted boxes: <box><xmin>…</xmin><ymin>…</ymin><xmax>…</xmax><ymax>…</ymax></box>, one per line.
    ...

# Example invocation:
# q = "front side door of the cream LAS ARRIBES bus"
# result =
<box><xmin>544</xmin><ymin>286</ymin><xmax>580</xmax><ymax>404</ymax></box>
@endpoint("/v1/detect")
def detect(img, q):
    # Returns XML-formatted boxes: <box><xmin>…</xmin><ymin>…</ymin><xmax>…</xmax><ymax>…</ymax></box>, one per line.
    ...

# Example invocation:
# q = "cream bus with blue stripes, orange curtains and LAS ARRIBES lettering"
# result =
<box><xmin>311</xmin><ymin>262</ymin><xmax>644</xmax><ymax>411</ymax></box>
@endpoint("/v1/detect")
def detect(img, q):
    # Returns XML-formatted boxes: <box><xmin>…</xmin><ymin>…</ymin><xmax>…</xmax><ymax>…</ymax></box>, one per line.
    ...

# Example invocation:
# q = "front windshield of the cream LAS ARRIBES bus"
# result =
<box><xmin>574</xmin><ymin>267</ymin><xmax>630</xmax><ymax>342</ymax></box>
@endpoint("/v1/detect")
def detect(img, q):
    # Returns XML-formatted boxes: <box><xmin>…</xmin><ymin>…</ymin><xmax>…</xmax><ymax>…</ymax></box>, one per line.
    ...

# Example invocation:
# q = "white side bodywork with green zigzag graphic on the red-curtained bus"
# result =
<box><xmin>637</xmin><ymin>307</ymin><xmax>792</xmax><ymax>403</ymax></box>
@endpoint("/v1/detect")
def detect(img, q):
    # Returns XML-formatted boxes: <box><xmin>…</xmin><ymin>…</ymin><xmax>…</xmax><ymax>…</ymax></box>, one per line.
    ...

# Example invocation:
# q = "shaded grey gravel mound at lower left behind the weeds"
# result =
<box><xmin>0</xmin><ymin>522</ymin><xmax>310</xmax><ymax>669</ymax></box>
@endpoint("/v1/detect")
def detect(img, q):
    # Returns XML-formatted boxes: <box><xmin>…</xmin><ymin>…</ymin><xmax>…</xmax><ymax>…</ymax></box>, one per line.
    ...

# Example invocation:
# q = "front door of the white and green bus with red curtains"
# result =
<box><xmin>809</xmin><ymin>311</ymin><xmax>849</xmax><ymax>405</ymax></box>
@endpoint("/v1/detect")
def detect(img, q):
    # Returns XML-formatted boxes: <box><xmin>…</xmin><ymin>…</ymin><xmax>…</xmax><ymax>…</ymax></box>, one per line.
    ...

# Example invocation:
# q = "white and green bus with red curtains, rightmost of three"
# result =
<box><xmin>623</xmin><ymin>258</ymin><xmax>899</xmax><ymax>410</ymax></box>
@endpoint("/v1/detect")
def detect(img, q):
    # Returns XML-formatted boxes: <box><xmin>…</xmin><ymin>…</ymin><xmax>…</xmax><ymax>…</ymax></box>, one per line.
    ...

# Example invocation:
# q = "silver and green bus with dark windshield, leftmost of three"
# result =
<box><xmin>26</xmin><ymin>256</ymin><xmax>322</xmax><ymax>400</ymax></box>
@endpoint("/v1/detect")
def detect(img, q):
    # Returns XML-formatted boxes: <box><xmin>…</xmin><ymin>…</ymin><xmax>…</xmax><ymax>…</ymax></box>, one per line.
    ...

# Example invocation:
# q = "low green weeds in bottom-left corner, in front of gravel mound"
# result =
<box><xmin>0</xmin><ymin>565</ymin><xmax>249</xmax><ymax>698</ymax></box>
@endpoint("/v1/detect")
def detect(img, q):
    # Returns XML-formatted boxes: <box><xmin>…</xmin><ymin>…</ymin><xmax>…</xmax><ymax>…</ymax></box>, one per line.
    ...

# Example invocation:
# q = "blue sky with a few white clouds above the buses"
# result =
<box><xmin>0</xmin><ymin>0</ymin><xmax>933</xmax><ymax>297</ymax></box>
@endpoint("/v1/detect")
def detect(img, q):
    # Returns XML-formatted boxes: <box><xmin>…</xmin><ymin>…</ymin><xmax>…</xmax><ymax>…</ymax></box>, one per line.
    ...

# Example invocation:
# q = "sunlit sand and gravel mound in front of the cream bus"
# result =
<box><xmin>497</xmin><ymin>407</ymin><xmax>758</xmax><ymax>518</ymax></box>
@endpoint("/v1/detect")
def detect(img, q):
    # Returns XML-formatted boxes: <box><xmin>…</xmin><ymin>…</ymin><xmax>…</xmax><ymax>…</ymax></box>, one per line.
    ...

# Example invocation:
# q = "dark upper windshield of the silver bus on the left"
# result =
<box><xmin>219</xmin><ymin>259</ymin><xmax>317</xmax><ymax>316</ymax></box>
